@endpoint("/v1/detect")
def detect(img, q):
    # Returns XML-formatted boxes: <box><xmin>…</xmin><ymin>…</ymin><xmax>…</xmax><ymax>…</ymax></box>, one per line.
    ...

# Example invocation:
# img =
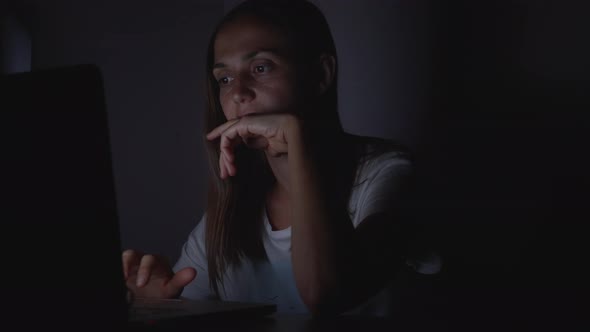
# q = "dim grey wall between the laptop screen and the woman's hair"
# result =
<box><xmin>11</xmin><ymin>0</ymin><xmax>223</xmax><ymax>260</ymax></box>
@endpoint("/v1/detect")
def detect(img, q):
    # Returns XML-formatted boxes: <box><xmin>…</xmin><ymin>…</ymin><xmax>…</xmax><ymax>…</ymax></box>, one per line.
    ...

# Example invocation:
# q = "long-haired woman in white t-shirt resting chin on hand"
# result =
<box><xmin>123</xmin><ymin>0</ymin><xmax>438</xmax><ymax>314</ymax></box>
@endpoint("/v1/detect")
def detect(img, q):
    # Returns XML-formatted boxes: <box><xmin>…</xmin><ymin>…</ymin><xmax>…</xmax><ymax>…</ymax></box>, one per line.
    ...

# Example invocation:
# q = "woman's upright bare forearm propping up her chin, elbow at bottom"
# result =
<box><xmin>288</xmin><ymin>118</ymin><xmax>361</xmax><ymax>313</ymax></box>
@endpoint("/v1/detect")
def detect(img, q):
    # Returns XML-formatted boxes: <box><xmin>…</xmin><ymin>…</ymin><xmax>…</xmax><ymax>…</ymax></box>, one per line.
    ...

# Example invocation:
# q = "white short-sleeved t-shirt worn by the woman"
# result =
<box><xmin>174</xmin><ymin>152</ymin><xmax>440</xmax><ymax>315</ymax></box>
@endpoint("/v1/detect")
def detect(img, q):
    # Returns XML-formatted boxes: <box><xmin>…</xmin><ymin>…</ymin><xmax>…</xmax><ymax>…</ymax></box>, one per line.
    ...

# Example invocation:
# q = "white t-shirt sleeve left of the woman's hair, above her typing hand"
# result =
<box><xmin>173</xmin><ymin>216</ymin><xmax>214</xmax><ymax>300</ymax></box>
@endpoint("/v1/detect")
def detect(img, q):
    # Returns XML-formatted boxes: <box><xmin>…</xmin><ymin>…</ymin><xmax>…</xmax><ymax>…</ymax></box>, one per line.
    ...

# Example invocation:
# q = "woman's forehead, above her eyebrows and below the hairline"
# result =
<box><xmin>213</xmin><ymin>17</ymin><xmax>289</xmax><ymax>62</ymax></box>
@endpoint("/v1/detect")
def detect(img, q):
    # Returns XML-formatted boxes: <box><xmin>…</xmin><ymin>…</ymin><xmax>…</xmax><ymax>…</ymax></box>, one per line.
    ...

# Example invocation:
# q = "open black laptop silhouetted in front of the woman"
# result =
<box><xmin>0</xmin><ymin>65</ymin><xmax>276</xmax><ymax>330</ymax></box>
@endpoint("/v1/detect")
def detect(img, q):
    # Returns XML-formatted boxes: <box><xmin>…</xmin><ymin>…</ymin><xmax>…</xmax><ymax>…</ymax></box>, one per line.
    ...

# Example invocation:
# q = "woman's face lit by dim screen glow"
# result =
<box><xmin>213</xmin><ymin>17</ymin><xmax>300</xmax><ymax>120</ymax></box>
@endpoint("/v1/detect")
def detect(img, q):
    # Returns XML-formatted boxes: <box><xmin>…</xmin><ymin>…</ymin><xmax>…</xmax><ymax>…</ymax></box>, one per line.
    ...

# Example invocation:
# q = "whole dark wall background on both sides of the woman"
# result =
<box><xmin>0</xmin><ymin>0</ymin><xmax>590</xmax><ymax>324</ymax></box>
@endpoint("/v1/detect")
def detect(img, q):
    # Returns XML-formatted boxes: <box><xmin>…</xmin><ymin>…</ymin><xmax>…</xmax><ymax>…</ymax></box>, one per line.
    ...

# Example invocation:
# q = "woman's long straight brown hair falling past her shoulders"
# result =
<box><xmin>205</xmin><ymin>0</ymin><xmax>357</xmax><ymax>297</ymax></box>
